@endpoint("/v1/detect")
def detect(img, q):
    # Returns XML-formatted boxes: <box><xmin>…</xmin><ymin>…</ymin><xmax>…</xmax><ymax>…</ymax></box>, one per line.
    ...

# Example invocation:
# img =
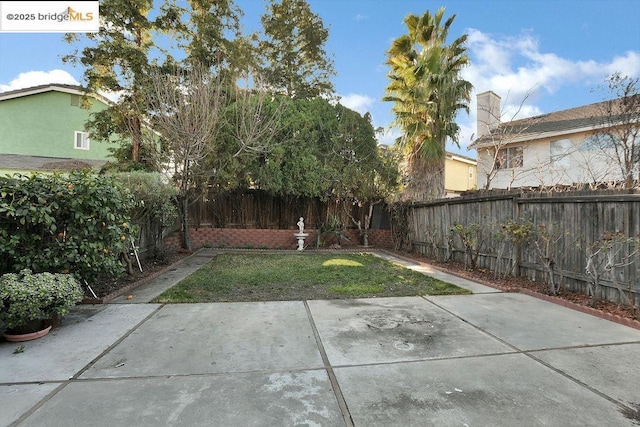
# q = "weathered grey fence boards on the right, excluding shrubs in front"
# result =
<box><xmin>408</xmin><ymin>190</ymin><xmax>640</xmax><ymax>304</ymax></box>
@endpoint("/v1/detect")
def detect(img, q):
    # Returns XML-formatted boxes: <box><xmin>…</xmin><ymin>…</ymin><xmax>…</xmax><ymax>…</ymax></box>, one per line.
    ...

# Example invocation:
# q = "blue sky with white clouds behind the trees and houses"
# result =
<box><xmin>0</xmin><ymin>0</ymin><xmax>640</xmax><ymax>158</ymax></box>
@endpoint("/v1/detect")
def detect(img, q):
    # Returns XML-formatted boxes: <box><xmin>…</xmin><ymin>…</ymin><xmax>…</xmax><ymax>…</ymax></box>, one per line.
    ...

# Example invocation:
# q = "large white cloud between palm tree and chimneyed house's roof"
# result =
<box><xmin>458</xmin><ymin>29</ymin><xmax>640</xmax><ymax>152</ymax></box>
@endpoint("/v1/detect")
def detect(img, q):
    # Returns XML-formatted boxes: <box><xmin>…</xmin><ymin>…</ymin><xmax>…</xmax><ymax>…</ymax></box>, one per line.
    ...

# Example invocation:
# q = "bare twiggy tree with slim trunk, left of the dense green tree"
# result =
<box><xmin>146</xmin><ymin>65</ymin><xmax>281</xmax><ymax>250</ymax></box>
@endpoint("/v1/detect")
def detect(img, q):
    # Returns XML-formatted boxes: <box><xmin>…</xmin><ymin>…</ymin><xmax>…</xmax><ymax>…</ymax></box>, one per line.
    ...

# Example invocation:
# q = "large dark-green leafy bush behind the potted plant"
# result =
<box><xmin>0</xmin><ymin>171</ymin><xmax>137</xmax><ymax>283</ymax></box>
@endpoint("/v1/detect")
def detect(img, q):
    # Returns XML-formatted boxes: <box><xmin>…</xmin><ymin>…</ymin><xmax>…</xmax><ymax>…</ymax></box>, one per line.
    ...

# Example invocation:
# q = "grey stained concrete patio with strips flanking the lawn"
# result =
<box><xmin>0</xmin><ymin>251</ymin><xmax>640</xmax><ymax>426</ymax></box>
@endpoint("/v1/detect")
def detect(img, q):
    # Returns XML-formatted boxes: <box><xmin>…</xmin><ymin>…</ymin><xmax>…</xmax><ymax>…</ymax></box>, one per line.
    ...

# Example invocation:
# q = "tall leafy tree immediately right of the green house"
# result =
<box><xmin>62</xmin><ymin>0</ymin><xmax>179</xmax><ymax>163</ymax></box>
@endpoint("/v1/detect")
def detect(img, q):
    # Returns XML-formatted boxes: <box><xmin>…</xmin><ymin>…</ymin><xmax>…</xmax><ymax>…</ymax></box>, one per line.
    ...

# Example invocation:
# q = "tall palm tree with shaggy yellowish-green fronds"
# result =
<box><xmin>383</xmin><ymin>8</ymin><xmax>472</xmax><ymax>200</ymax></box>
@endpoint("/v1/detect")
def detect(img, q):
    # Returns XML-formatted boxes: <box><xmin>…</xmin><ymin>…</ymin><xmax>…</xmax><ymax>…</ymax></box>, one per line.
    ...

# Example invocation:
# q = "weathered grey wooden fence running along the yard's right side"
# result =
<box><xmin>407</xmin><ymin>190</ymin><xmax>640</xmax><ymax>305</ymax></box>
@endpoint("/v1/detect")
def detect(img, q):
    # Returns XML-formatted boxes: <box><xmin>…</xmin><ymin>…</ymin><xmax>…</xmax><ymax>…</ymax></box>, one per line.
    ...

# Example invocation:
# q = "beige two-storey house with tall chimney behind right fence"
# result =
<box><xmin>469</xmin><ymin>91</ymin><xmax>638</xmax><ymax>189</ymax></box>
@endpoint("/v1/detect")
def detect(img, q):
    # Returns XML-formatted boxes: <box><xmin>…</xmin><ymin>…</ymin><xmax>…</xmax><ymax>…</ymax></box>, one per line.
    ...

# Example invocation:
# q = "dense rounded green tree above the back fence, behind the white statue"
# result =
<box><xmin>244</xmin><ymin>98</ymin><xmax>397</xmax><ymax>216</ymax></box>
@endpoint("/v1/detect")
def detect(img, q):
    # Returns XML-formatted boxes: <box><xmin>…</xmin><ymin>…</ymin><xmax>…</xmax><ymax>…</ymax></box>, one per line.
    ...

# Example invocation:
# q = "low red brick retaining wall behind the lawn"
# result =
<box><xmin>164</xmin><ymin>228</ymin><xmax>393</xmax><ymax>250</ymax></box>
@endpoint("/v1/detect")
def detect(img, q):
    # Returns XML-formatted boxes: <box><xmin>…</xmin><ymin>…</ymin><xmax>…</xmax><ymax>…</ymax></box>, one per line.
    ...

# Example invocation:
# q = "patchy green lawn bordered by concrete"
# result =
<box><xmin>153</xmin><ymin>253</ymin><xmax>471</xmax><ymax>303</ymax></box>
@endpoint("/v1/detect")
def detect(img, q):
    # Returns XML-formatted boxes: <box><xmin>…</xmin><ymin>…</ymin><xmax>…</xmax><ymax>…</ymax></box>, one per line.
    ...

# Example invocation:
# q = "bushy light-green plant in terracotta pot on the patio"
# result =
<box><xmin>0</xmin><ymin>269</ymin><xmax>83</xmax><ymax>341</ymax></box>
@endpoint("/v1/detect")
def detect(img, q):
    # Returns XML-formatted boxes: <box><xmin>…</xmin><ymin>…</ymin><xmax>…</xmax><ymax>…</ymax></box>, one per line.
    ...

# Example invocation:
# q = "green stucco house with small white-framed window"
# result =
<box><xmin>0</xmin><ymin>84</ymin><xmax>111</xmax><ymax>175</ymax></box>
